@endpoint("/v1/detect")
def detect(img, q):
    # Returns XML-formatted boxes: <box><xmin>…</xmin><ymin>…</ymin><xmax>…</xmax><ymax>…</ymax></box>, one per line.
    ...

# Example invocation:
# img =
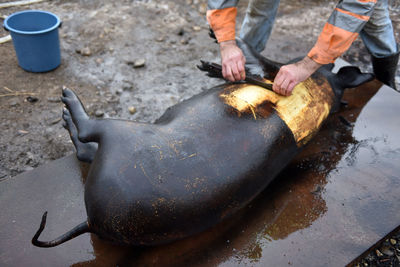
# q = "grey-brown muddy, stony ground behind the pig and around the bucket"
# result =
<box><xmin>0</xmin><ymin>0</ymin><xmax>400</xmax><ymax>179</ymax></box>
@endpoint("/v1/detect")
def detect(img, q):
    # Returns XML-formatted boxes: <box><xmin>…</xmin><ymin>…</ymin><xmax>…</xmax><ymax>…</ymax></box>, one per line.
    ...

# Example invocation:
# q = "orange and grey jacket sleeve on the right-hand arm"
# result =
<box><xmin>308</xmin><ymin>0</ymin><xmax>379</xmax><ymax>64</ymax></box>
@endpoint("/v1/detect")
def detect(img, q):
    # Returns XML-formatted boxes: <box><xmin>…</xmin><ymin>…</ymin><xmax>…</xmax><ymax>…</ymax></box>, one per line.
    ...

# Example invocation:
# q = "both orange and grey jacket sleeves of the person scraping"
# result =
<box><xmin>207</xmin><ymin>0</ymin><xmax>379</xmax><ymax>64</ymax></box>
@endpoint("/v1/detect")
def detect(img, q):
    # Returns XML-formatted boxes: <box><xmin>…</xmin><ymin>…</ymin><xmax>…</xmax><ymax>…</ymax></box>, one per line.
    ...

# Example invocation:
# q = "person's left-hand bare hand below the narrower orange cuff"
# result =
<box><xmin>219</xmin><ymin>40</ymin><xmax>246</xmax><ymax>82</ymax></box>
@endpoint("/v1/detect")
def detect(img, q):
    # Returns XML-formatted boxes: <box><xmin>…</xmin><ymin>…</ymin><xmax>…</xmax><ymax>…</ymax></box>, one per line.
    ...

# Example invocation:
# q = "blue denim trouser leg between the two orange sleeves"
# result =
<box><xmin>239</xmin><ymin>0</ymin><xmax>279</xmax><ymax>52</ymax></box>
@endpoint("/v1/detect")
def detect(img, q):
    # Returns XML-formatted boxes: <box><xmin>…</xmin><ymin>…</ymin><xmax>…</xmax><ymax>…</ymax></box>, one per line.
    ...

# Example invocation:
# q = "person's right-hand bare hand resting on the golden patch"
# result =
<box><xmin>272</xmin><ymin>57</ymin><xmax>322</xmax><ymax>96</ymax></box>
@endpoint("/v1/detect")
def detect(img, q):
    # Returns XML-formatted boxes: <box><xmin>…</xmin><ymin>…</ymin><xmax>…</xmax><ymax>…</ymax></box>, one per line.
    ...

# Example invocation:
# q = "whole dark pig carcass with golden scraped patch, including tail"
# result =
<box><xmin>32</xmin><ymin>40</ymin><xmax>372</xmax><ymax>247</ymax></box>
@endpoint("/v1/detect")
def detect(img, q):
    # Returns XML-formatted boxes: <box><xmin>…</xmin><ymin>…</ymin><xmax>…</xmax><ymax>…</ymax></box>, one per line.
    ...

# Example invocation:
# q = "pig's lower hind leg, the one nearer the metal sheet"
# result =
<box><xmin>62</xmin><ymin>108</ymin><xmax>98</xmax><ymax>163</ymax></box>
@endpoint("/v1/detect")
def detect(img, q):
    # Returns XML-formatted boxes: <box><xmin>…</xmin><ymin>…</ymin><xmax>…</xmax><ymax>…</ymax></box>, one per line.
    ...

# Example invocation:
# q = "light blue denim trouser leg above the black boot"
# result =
<box><xmin>360</xmin><ymin>0</ymin><xmax>398</xmax><ymax>58</ymax></box>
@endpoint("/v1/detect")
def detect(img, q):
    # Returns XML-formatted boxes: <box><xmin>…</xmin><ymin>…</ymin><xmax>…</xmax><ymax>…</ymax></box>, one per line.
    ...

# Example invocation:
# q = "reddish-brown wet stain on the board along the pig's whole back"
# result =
<box><xmin>72</xmin><ymin>82</ymin><xmax>380</xmax><ymax>266</ymax></box>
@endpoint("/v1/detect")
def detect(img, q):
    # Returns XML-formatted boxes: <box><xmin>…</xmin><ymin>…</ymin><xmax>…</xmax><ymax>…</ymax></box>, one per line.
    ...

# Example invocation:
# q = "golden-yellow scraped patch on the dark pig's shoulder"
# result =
<box><xmin>220</xmin><ymin>79</ymin><xmax>334</xmax><ymax>146</ymax></box>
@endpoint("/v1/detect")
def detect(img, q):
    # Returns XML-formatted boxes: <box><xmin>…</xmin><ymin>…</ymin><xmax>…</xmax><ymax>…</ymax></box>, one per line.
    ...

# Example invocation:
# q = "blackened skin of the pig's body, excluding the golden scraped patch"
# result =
<box><xmin>64</xmin><ymin>88</ymin><xmax>298</xmax><ymax>245</ymax></box>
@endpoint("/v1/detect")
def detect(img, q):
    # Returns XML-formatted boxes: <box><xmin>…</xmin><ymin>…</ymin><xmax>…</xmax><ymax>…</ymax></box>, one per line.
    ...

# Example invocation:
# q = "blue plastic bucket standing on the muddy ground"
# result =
<box><xmin>4</xmin><ymin>10</ymin><xmax>61</xmax><ymax>72</ymax></box>
